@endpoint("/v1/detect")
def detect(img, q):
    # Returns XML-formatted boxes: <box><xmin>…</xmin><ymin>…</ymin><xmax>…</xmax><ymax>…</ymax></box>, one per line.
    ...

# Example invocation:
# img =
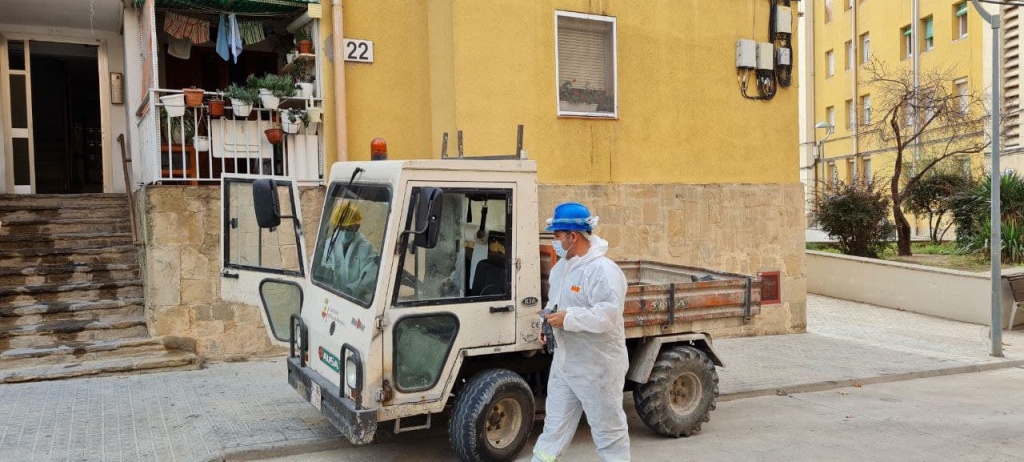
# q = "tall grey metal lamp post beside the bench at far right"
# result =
<box><xmin>971</xmin><ymin>0</ymin><xmax>1002</xmax><ymax>358</ymax></box>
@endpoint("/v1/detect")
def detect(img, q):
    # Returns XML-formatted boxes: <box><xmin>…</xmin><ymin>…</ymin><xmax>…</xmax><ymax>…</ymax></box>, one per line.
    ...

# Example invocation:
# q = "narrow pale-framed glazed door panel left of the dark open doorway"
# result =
<box><xmin>0</xmin><ymin>36</ymin><xmax>36</xmax><ymax>194</ymax></box>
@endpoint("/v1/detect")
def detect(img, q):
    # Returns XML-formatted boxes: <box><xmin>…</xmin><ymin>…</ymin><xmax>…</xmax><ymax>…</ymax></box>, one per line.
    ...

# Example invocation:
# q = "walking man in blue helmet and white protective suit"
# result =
<box><xmin>532</xmin><ymin>203</ymin><xmax>630</xmax><ymax>462</ymax></box>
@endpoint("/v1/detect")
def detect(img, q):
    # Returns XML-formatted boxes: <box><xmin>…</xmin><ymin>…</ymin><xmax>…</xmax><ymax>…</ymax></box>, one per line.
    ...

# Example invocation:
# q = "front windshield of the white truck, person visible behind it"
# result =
<box><xmin>311</xmin><ymin>183</ymin><xmax>391</xmax><ymax>307</ymax></box>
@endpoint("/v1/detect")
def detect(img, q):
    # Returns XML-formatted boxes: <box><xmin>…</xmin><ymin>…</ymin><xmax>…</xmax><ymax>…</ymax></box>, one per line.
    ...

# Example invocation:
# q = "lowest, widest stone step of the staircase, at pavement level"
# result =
<box><xmin>0</xmin><ymin>350</ymin><xmax>202</xmax><ymax>383</ymax></box>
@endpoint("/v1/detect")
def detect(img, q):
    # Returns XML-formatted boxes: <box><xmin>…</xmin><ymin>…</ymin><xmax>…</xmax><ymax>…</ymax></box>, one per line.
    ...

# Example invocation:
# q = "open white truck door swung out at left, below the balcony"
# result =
<box><xmin>220</xmin><ymin>174</ymin><xmax>307</xmax><ymax>345</ymax></box>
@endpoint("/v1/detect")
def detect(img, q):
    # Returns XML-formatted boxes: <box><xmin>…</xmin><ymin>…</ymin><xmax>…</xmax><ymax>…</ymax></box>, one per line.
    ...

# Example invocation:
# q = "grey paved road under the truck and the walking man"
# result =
<box><xmin>258</xmin><ymin>368</ymin><xmax>1024</xmax><ymax>462</ymax></box>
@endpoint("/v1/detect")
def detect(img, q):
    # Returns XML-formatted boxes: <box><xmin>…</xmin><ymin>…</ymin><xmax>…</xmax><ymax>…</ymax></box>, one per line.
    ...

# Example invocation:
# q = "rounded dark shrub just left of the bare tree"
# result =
<box><xmin>817</xmin><ymin>184</ymin><xmax>895</xmax><ymax>258</ymax></box>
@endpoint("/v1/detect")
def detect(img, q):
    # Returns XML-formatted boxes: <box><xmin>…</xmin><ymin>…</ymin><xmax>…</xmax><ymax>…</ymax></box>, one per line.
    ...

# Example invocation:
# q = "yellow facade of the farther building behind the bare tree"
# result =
<box><xmin>813</xmin><ymin>0</ymin><xmax>988</xmax><ymax>189</ymax></box>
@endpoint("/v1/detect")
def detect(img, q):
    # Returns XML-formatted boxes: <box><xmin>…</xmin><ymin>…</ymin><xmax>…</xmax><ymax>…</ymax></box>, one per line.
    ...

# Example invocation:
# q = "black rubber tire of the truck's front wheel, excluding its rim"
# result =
<box><xmin>449</xmin><ymin>369</ymin><xmax>537</xmax><ymax>462</ymax></box>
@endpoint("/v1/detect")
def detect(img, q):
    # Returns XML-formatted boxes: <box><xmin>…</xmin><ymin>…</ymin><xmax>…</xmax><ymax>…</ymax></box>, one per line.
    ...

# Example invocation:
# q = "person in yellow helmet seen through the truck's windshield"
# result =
<box><xmin>324</xmin><ymin>202</ymin><xmax>380</xmax><ymax>301</ymax></box>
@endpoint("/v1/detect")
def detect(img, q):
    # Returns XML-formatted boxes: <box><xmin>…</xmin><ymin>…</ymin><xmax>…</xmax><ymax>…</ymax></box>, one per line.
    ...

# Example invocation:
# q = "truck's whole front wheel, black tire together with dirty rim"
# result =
<box><xmin>449</xmin><ymin>369</ymin><xmax>536</xmax><ymax>462</ymax></box>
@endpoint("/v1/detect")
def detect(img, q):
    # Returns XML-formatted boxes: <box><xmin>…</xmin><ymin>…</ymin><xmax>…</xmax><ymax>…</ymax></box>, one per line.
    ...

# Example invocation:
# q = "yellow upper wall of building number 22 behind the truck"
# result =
<box><xmin>322</xmin><ymin>0</ymin><xmax>799</xmax><ymax>184</ymax></box>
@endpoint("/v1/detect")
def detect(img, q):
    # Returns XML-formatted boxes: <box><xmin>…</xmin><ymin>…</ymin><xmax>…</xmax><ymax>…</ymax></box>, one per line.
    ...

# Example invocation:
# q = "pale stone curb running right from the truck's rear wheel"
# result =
<box><xmin>718</xmin><ymin>360</ymin><xmax>1024</xmax><ymax>402</ymax></box>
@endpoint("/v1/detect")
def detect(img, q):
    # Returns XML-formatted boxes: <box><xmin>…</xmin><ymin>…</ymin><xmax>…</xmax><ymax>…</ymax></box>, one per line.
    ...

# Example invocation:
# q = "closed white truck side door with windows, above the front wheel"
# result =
<box><xmin>383</xmin><ymin>181</ymin><xmax>518</xmax><ymax>405</ymax></box>
